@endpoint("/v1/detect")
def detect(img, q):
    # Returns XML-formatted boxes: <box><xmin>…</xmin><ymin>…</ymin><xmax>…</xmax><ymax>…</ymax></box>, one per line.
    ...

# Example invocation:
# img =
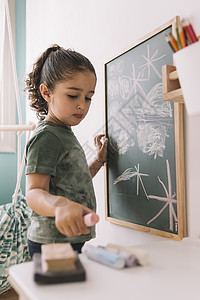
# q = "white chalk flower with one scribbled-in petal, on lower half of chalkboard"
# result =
<box><xmin>114</xmin><ymin>163</ymin><xmax>149</xmax><ymax>199</ymax></box>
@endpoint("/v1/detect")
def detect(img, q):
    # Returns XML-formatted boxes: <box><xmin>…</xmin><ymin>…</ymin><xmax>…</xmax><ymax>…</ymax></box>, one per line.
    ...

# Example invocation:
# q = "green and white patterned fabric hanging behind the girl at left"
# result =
<box><xmin>0</xmin><ymin>192</ymin><xmax>31</xmax><ymax>294</ymax></box>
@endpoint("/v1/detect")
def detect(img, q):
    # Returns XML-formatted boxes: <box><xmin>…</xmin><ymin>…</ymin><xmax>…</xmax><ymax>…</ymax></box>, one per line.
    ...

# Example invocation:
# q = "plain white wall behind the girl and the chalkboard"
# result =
<box><xmin>27</xmin><ymin>0</ymin><xmax>200</xmax><ymax>245</ymax></box>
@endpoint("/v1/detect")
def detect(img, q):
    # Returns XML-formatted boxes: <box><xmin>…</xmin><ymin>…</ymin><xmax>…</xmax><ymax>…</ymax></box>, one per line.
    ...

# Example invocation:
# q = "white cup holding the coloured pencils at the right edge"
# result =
<box><xmin>173</xmin><ymin>42</ymin><xmax>200</xmax><ymax>115</ymax></box>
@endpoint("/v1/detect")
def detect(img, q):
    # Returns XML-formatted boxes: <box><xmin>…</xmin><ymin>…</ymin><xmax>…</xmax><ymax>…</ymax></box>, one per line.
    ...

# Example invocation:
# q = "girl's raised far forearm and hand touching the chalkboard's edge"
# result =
<box><xmin>89</xmin><ymin>134</ymin><xmax>108</xmax><ymax>178</ymax></box>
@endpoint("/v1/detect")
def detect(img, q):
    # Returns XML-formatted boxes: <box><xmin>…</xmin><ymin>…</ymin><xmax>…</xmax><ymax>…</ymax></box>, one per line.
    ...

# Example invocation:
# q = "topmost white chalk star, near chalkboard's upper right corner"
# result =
<box><xmin>140</xmin><ymin>45</ymin><xmax>165</xmax><ymax>79</ymax></box>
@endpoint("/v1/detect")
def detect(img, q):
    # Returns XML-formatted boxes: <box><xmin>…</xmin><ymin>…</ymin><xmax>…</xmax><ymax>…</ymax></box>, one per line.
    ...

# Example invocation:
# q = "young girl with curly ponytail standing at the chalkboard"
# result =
<box><xmin>26</xmin><ymin>45</ymin><xmax>107</xmax><ymax>257</ymax></box>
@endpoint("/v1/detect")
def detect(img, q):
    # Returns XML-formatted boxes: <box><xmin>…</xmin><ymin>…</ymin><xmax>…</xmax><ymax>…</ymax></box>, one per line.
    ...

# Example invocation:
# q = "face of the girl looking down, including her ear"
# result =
<box><xmin>40</xmin><ymin>71</ymin><xmax>96</xmax><ymax>127</ymax></box>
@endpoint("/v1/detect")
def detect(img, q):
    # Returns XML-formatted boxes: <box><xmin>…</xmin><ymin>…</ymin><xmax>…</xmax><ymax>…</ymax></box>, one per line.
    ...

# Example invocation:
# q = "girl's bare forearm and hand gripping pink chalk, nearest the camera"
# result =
<box><xmin>26</xmin><ymin>173</ymin><xmax>92</xmax><ymax>237</ymax></box>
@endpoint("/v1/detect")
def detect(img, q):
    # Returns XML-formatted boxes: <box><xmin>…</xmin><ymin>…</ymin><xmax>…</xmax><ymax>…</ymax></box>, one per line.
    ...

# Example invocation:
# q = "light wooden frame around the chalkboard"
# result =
<box><xmin>104</xmin><ymin>17</ymin><xmax>187</xmax><ymax>240</ymax></box>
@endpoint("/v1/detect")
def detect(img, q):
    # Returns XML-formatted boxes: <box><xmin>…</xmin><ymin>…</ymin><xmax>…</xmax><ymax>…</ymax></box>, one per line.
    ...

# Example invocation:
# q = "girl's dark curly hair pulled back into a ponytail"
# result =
<box><xmin>25</xmin><ymin>44</ymin><xmax>96</xmax><ymax>120</ymax></box>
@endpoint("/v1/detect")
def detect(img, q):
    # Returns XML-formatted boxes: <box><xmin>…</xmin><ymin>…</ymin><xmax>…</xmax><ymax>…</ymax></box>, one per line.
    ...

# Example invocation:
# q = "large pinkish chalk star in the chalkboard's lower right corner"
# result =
<box><xmin>147</xmin><ymin>160</ymin><xmax>178</xmax><ymax>231</ymax></box>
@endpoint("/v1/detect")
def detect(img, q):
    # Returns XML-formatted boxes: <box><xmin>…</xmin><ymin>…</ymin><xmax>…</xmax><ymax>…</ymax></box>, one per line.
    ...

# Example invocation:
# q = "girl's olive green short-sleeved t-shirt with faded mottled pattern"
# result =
<box><xmin>26</xmin><ymin>121</ymin><xmax>96</xmax><ymax>243</ymax></box>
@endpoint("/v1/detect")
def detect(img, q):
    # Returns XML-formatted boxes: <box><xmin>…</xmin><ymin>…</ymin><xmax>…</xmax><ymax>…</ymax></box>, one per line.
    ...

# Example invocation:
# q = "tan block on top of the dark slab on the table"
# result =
<box><xmin>41</xmin><ymin>243</ymin><xmax>77</xmax><ymax>272</ymax></box>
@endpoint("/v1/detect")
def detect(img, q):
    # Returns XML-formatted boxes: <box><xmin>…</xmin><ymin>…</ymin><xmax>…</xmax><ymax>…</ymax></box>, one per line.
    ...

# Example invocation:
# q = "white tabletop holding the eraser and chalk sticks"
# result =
<box><xmin>10</xmin><ymin>238</ymin><xmax>200</xmax><ymax>300</ymax></box>
